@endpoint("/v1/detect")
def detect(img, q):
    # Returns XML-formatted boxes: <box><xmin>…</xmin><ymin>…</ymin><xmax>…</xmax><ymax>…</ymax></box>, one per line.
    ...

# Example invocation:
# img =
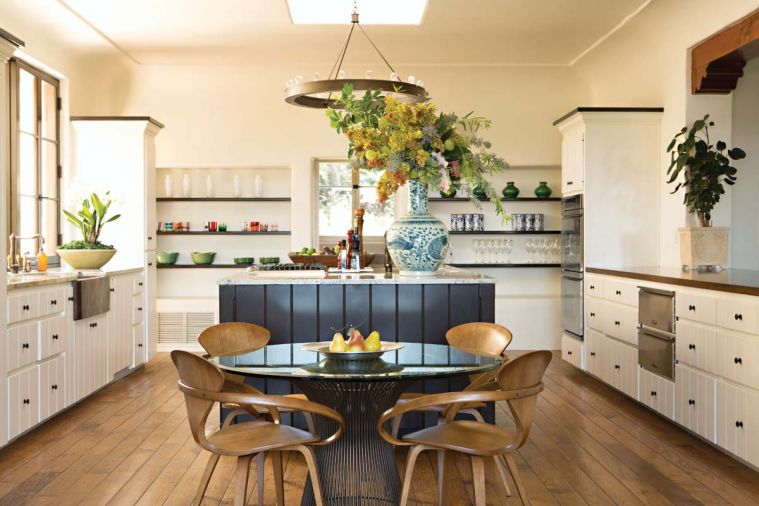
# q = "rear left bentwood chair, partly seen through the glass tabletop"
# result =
<box><xmin>198</xmin><ymin>322</ymin><xmax>314</xmax><ymax>432</ymax></box>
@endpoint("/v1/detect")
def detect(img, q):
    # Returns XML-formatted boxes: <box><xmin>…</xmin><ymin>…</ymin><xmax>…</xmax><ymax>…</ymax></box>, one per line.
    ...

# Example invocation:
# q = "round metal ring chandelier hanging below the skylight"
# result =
<box><xmin>285</xmin><ymin>1</ymin><xmax>427</xmax><ymax>109</ymax></box>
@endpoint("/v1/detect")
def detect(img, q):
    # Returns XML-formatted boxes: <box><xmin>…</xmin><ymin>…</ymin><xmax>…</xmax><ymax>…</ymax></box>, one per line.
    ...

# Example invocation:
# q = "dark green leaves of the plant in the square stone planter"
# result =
<box><xmin>667</xmin><ymin>114</ymin><xmax>746</xmax><ymax>226</ymax></box>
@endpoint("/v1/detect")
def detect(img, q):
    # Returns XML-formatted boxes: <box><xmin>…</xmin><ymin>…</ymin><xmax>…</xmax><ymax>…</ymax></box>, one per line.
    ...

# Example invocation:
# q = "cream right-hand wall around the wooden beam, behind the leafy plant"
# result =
<box><xmin>574</xmin><ymin>0</ymin><xmax>757</xmax><ymax>266</ymax></box>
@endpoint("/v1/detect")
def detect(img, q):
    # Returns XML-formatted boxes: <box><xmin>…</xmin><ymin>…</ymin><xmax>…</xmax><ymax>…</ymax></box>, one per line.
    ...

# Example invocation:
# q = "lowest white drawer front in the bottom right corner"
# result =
<box><xmin>716</xmin><ymin>380</ymin><xmax>759</xmax><ymax>466</ymax></box>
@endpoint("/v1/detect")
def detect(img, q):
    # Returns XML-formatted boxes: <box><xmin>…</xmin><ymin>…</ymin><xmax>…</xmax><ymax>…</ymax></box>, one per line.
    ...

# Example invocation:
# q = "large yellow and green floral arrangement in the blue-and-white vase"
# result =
<box><xmin>327</xmin><ymin>84</ymin><xmax>509</xmax><ymax>215</ymax></box>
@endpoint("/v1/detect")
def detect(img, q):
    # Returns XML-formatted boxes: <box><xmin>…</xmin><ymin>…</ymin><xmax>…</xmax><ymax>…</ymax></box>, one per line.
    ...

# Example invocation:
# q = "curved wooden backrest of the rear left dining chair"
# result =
<box><xmin>198</xmin><ymin>322</ymin><xmax>271</xmax><ymax>357</ymax></box>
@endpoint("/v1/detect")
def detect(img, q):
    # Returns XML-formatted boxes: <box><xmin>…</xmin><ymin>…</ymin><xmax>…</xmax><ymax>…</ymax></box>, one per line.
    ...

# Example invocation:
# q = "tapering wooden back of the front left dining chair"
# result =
<box><xmin>171</xmin><ymin>350</ymin><xmax>224</xmax><ymax>449</ymax></box>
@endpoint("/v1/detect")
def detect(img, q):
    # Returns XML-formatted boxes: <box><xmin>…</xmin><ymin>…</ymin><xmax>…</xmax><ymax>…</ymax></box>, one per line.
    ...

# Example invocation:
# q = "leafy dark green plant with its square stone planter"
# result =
<box><xmin>667</xmin><ymin>114</ymin><xmax>746</xmax><ymax>270</ymax></box>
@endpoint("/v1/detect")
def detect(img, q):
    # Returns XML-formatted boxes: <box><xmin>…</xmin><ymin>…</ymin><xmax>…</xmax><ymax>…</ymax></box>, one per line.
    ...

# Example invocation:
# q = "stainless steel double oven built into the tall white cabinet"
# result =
<box><xmin>561</xmin><ymin>195</ymin><xmax>585</xmax><ymax>339</ymax></box>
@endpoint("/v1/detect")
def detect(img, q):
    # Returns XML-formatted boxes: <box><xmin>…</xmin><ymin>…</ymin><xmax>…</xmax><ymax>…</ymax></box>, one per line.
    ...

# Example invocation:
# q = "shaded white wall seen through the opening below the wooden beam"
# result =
<box><xmin>732</xmin><ymin>58</ymin><xmax>759</xmax><ymax>269</ymax></box>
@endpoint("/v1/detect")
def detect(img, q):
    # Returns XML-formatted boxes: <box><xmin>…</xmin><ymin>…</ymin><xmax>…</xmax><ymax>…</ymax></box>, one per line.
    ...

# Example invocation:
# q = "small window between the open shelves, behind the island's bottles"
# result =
<box><xmin>316</xmin><ymin>160</ymin><xmax>395</xmax><ymax>246</ymax></box>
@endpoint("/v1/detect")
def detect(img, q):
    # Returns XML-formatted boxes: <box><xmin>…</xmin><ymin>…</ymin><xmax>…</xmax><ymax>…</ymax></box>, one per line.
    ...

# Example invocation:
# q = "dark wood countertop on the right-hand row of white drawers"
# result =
<box><xmin>585</xmin><ymin>267</ymin><xmax>759</xmax><ymax>296</ymax></box>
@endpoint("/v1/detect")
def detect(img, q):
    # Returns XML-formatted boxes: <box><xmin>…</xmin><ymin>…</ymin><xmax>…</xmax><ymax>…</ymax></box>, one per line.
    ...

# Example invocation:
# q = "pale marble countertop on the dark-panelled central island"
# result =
<box><xmin>218</xmin><ymin>266</ymin><xmax>495</xmax><ymax>285</ymax></box>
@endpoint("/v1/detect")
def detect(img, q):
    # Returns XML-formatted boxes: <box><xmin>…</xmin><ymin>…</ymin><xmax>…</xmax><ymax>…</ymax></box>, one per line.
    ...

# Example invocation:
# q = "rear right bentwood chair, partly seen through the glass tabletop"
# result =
<box><xmin>392</xmin><ymin>322</ymin><xmax>512</xmax><ymax>437</ymax></box>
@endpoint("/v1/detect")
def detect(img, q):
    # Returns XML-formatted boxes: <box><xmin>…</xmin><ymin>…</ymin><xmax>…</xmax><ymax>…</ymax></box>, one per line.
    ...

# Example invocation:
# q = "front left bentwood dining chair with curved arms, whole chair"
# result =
<box><xmin>171</xmin><ymin>350</ymin><xmax>345</xmax><ymax>506</ymax></box>
